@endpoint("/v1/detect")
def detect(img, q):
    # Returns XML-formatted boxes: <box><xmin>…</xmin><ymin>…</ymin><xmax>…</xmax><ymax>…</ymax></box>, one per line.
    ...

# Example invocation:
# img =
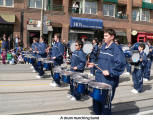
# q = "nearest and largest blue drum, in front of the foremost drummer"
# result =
<box><xmin>88</xmin><ymin>82</ymin><xmax>112</xmax><ymax>102</ymax></box>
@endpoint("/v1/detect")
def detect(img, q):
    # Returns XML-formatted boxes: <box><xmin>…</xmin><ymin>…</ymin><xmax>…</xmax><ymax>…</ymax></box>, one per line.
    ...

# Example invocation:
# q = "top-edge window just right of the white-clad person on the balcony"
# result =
<box><xmin>85</xmin><ymin>0</ymin><xmax>97</xmax><ymax>14</ymax></box>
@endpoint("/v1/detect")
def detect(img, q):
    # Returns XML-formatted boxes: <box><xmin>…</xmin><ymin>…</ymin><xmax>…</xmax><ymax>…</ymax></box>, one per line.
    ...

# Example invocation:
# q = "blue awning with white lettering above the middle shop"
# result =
<box><xmin>70</xmin><ymin>17</ymin><xmax>103</xmax><ymax>29</ymax></box>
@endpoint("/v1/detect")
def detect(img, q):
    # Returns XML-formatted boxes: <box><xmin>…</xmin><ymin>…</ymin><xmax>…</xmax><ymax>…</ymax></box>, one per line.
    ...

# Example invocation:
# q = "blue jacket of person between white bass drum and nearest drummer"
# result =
<box><xmin>90</xmin><ymin>44</ymin><xmax>98</xmax><ymax>62</ymax></box>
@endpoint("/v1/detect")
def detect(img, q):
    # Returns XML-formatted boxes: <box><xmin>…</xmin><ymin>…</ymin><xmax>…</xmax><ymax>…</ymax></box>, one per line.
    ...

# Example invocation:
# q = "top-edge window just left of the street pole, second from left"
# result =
<box><xmin>29</xmin><ymin>0</ymin><xmax>42</xmax><ymax>8</ymax></box>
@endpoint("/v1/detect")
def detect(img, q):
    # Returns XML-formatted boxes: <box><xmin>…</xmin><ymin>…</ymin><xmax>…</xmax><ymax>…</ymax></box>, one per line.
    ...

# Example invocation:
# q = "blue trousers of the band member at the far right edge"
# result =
<box><xmin>143</xmin><ymin>60</ymin><xmax>152</xmax><ymax>80</ymax></box>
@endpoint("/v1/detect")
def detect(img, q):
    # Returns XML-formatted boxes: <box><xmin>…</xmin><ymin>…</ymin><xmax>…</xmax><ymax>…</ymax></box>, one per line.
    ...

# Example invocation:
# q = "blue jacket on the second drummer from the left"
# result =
<box><xmin>37</xmin><ymin>42</ymin><xmax>47</xmax><ymax>57</ymax></box>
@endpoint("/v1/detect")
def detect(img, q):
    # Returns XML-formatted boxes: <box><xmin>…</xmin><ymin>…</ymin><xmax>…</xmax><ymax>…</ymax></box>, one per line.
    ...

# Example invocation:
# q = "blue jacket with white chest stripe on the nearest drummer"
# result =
<box><xmin>96</xmin><ymin>43</ymin><xmax>126</xmax><ymax>87</ymax></box>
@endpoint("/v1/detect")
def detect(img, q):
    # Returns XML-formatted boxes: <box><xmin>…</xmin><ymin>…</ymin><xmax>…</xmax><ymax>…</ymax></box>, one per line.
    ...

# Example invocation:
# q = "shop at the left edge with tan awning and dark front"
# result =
<box><xmin>0</xmin><ymin>14</ymin><xmax>15</xmax><ymax>37</ymax></box>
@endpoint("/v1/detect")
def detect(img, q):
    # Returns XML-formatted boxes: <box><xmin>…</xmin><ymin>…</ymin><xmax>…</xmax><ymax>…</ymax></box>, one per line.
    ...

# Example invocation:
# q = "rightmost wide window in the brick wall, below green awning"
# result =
<box><xmin>132</xmin><ymin>8</ymin><xmax>150</xmax><ymax>22</ymax></box>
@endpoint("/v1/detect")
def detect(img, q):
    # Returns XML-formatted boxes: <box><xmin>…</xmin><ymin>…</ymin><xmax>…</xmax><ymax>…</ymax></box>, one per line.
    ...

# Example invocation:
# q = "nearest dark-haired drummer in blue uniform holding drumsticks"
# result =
<box><xmin>88</xmin><ymin>29</ymin><xmax>126</xmax><ymax>115</ymax></box>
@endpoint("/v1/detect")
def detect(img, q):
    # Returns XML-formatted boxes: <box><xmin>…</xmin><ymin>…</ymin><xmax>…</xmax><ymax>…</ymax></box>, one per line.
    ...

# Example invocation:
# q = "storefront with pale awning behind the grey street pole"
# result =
<box><xmin>27</xmin><ymin>19</ymin><xmax>53</xmax><ymax>46</ymax></box>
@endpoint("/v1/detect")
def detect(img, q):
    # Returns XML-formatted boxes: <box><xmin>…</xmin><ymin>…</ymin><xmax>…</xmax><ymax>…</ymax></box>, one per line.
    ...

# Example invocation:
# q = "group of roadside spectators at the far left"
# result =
<box><xmin>0</xmin><ymin>34</ymin><xmax>23</xmax><ymax>64</ymax></box>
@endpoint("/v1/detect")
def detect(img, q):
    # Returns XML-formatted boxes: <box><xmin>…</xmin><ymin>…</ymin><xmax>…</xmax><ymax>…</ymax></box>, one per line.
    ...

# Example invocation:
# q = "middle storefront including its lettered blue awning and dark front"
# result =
<box><xmin>69</xmin><ymin>17</ymin><xmax>103</xmax><ymax>41</ymax></box>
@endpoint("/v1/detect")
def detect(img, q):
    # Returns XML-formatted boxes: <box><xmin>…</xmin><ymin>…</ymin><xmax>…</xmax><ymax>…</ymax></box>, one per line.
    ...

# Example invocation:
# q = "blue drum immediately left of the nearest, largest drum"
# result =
<box><xmin>73</xmin><ymin>79</ymin><xmax>91</xmax><ymax>94</ymax></box>
